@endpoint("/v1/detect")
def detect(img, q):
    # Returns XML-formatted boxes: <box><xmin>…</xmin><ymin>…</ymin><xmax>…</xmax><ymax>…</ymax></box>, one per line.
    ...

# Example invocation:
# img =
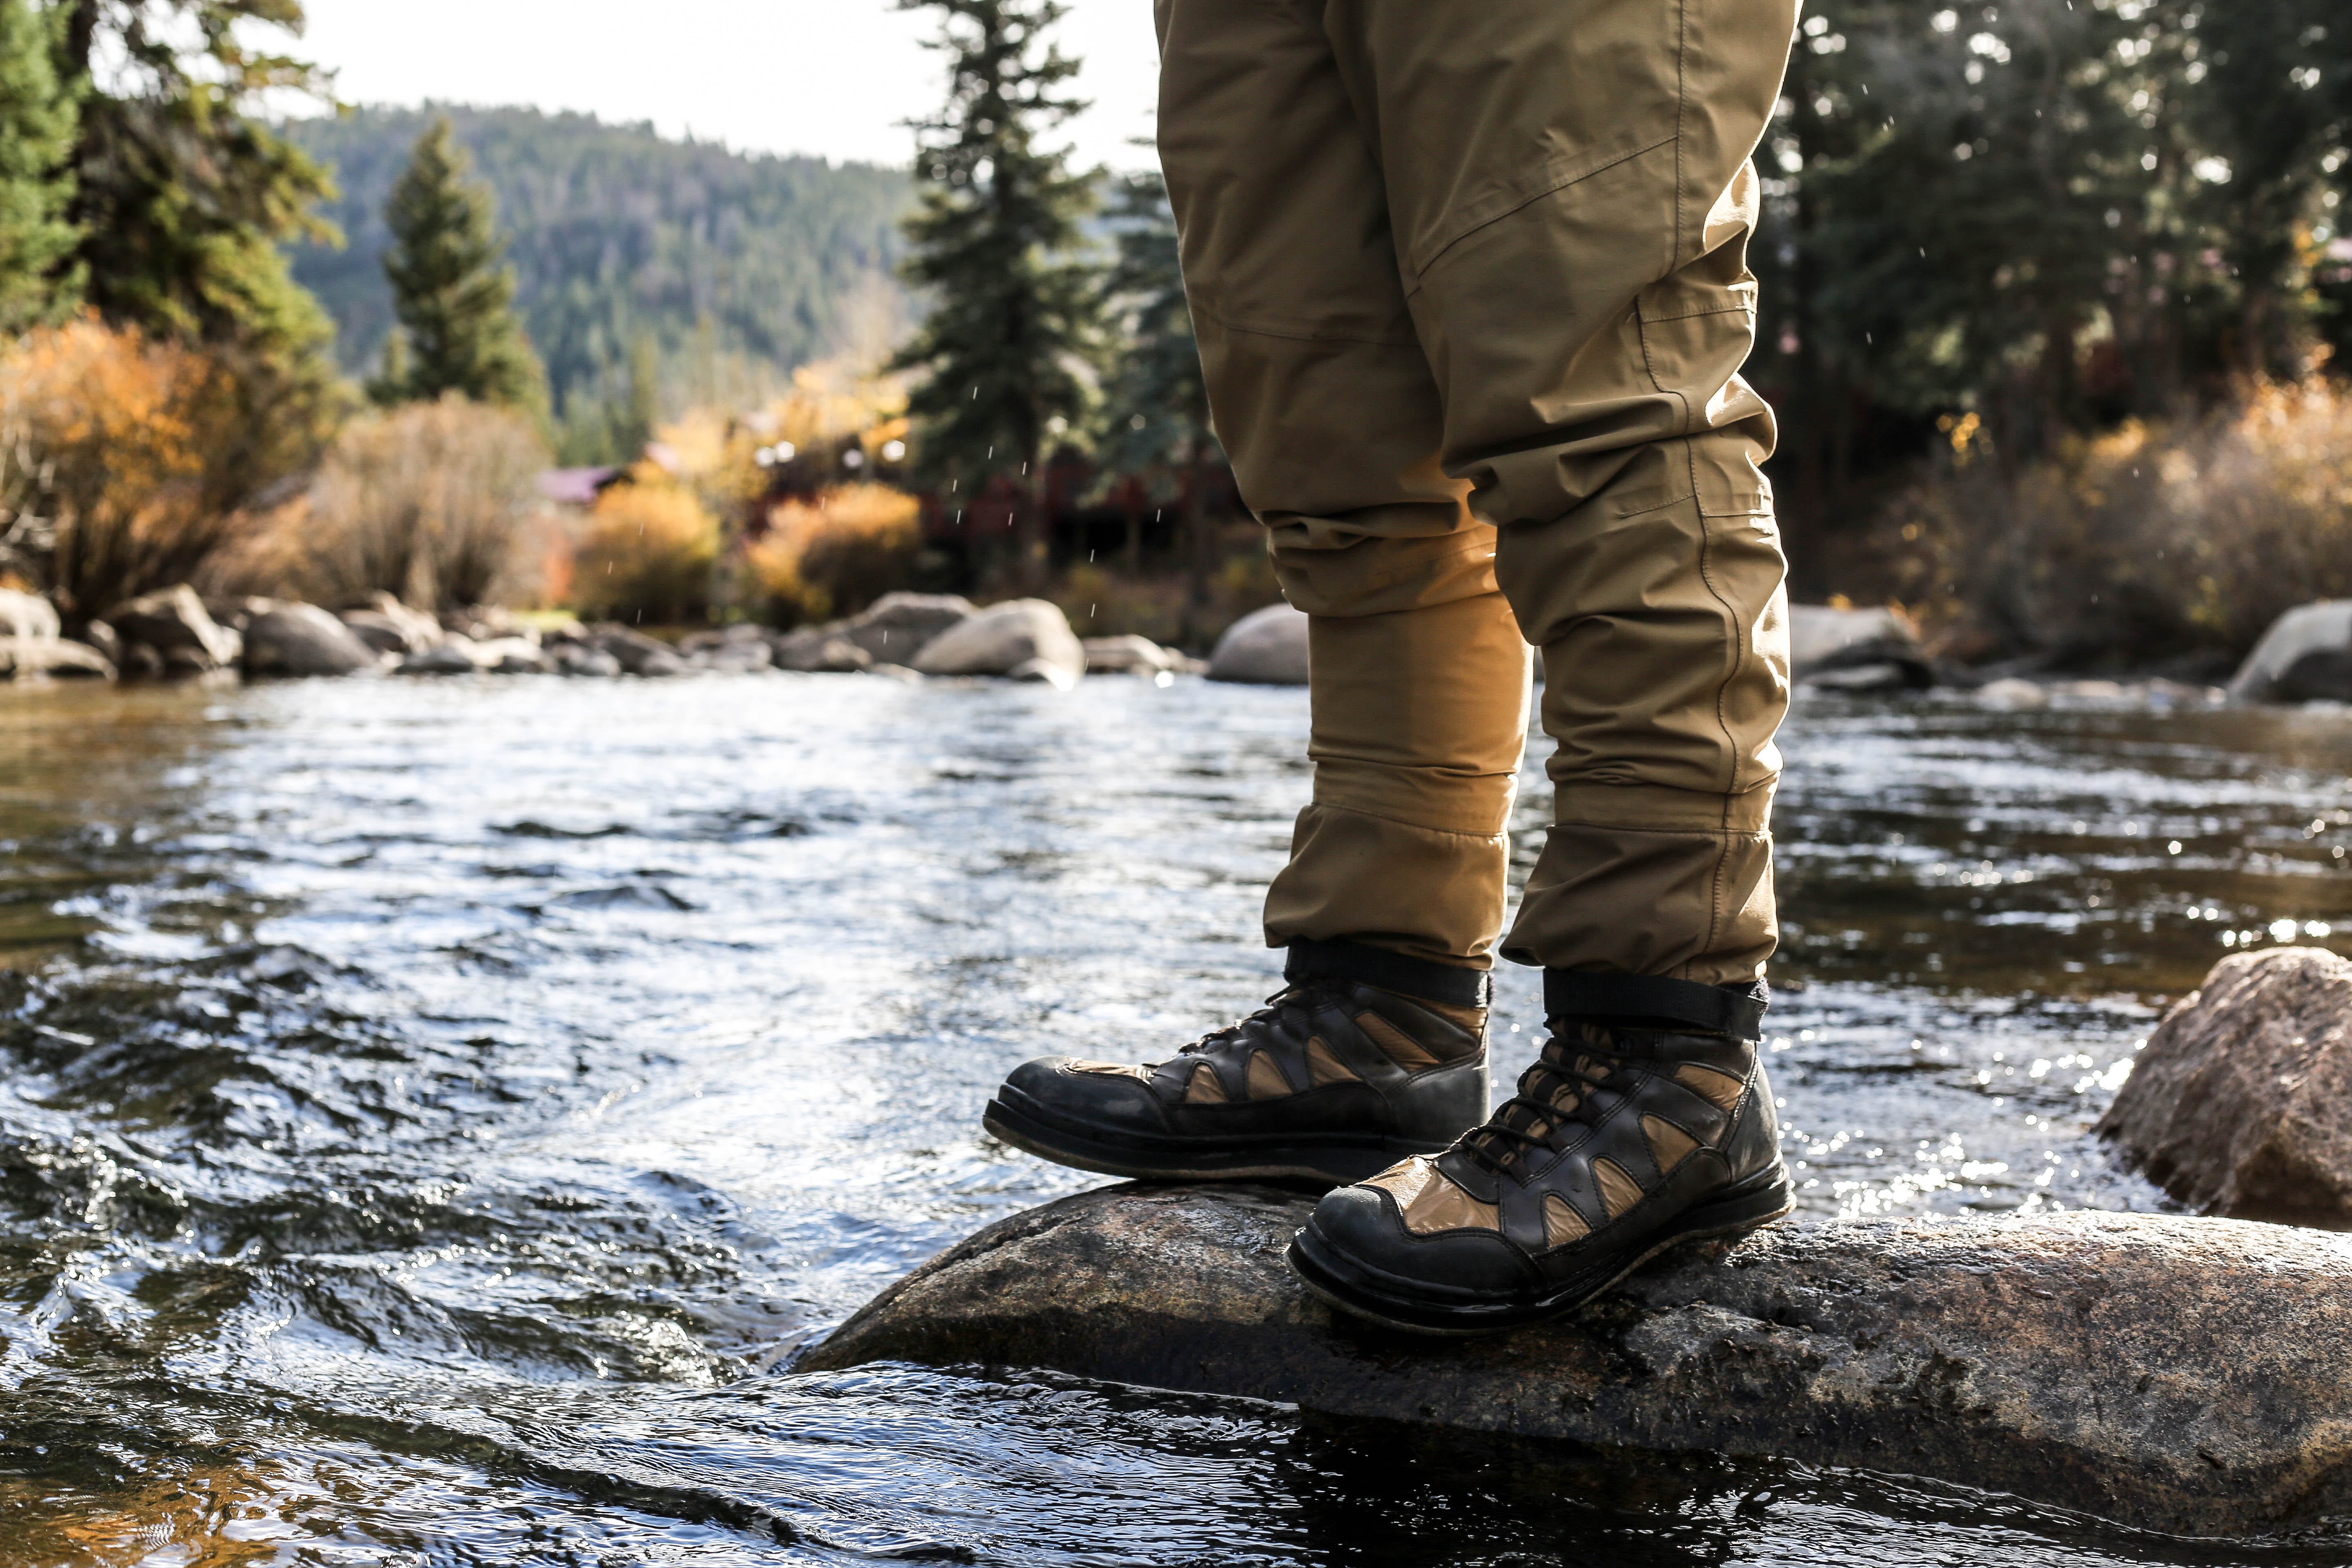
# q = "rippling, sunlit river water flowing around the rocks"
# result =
<box><xmin>0</xmin><ymin>675</ymin><xmax>2352</xmax><ymax>1568</ymax></box>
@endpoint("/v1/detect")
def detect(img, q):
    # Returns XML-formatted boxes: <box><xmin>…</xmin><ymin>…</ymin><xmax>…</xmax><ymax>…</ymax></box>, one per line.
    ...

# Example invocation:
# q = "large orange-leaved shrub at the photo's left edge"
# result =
<box><xmin>0</xmin><ymin>315</ymin><xmax>315</xmax><ymax>625</ymax></box>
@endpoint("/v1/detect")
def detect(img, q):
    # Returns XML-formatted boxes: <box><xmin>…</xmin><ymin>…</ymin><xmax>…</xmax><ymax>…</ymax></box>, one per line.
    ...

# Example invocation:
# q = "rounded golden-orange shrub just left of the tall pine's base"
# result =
<box><xmin>743</xmin><ymin>484</ymin><xmax>922</xmax><ymax>625</ymax></box>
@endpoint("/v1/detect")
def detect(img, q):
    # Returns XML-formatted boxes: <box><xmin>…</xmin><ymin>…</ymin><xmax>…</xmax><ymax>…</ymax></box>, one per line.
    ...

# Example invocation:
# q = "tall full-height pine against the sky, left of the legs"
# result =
<box><xmin>894</xmin><ymin>0</ymin><xmax>1101</xmax><ymax>581</ymax></box>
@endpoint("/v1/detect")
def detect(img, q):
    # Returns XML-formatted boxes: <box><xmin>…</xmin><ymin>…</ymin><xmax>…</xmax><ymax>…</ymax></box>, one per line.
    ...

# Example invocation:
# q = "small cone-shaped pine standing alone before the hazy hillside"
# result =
<box><xmin>383</xmin><ymin>118</ymin><xmax>546</xmax><ymax>411</ymax></box>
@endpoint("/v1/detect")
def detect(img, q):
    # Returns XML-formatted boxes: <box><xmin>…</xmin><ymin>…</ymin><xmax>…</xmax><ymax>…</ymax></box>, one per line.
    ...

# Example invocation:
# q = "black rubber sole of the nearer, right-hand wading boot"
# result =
<box><xmin>1287</xmin><ymin>1166</ymin><xmax>1797</xmax><ymax>1340</ymax></box>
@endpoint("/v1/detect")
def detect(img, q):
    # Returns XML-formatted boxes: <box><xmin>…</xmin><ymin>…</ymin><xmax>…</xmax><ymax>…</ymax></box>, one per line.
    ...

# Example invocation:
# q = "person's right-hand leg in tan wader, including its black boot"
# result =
<box><xmin>1294</xmin><ymin>0</ymin><xmax>1795</xmax><ymax>1328</ymax></box>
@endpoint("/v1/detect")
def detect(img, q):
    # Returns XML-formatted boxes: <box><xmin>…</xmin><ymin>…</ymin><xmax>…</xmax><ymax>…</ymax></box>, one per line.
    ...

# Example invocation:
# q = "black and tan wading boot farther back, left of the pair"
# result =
<box><xmin>981</xmin><ymin>940</ymin><xmax>1486</xmax><ymax>1183</ymax></box>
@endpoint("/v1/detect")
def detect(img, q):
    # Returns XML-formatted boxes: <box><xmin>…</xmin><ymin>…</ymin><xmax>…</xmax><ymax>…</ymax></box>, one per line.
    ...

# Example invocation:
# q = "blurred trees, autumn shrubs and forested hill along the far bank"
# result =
<box><xmin>0</xmin><ymin>0</ymin><xmax>2352</xmax><ymax>673</ymax></box>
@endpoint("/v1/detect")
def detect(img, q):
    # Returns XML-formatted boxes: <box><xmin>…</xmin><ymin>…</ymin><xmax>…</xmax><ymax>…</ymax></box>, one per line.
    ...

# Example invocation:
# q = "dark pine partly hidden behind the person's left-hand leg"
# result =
<box><xmin>1098</xmin><ymin>174</ymin><xmax>1218</xmax><ymax>642</ymax></box>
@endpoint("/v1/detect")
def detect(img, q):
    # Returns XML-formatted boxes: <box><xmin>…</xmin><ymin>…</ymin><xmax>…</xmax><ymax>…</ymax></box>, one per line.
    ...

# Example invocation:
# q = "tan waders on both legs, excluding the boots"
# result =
<box><xmin>1157</xmin><ymin>0</ymin><xmax>1797</xmax><ymax>982</ymax></box>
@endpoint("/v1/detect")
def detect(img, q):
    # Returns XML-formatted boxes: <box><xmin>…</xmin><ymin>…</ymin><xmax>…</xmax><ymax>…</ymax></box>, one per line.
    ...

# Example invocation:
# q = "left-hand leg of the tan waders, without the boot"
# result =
<box><xmin>1157</xmin><ymin>0</ymin><xmax>1529</xmax><ymax>969</ymax></box>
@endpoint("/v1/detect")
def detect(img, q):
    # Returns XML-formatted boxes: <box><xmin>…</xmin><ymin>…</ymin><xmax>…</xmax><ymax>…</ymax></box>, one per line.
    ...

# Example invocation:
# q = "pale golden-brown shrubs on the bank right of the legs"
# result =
<box><xmin>1879</xmin><ymin>381</ymin><xmax>2352</xmax><ymax>663</ymax></box>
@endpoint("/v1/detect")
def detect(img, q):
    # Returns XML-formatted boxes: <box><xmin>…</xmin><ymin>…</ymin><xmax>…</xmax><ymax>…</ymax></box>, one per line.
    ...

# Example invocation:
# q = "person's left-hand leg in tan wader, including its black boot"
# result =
<box><xmin>985</xmin><ymin>0</ymin><xmax>1529</xmax><ymax>1180</ymax></box>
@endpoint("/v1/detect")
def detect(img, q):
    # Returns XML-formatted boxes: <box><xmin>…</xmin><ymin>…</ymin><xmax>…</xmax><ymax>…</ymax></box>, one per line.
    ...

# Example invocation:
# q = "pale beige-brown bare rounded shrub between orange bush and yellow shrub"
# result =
<box><xmin>289</xmin><ymin>395</ymin><xmax>548</xmax><ymax>609</ymax></box>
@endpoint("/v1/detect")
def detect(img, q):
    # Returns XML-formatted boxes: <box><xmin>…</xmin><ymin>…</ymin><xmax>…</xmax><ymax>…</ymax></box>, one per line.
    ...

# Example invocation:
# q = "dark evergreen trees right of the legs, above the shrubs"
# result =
<box><xmin>1750</xmin><ymin>0</ymin><xmax>2352</xmax><ymax>557</ymax></box>
